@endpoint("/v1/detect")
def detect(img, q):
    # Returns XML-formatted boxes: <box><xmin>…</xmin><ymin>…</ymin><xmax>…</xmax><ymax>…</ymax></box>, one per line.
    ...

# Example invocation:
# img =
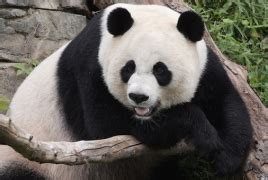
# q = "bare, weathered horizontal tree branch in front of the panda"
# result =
<box><xmin>0</xmin><ymin>114</ymin><xmax>194</xmax><ymax>165</ymax></box>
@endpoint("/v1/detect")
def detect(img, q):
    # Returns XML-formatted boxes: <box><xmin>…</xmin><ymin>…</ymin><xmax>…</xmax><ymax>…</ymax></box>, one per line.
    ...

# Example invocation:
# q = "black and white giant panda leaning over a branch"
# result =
<box><xmin>0</xmin><ymin>4</ymin><xmax>252</xmax><ymax>180</ymax></box>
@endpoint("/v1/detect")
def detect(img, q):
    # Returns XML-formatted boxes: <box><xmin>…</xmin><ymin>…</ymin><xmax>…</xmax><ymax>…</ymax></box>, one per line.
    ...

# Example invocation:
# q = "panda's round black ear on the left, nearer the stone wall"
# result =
<box><xmin>107</xmin><ymin>8</ymin><xmax>134</xmax><ymax>36</ymax></box>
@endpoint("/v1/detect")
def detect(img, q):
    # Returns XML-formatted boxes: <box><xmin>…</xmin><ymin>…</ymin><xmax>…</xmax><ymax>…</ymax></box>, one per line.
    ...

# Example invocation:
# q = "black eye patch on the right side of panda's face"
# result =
<box><xmin>153</xmin><ymin>62</ymin><xmax>172</xmax><ymax>86</ymax></box>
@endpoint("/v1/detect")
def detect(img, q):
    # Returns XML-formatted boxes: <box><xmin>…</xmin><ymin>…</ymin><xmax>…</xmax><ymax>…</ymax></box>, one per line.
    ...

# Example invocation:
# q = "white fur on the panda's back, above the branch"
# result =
<box><xmin>8</xmin><ymin>41</ymin><xmax>70</xmax><ymax>141</ymax></box>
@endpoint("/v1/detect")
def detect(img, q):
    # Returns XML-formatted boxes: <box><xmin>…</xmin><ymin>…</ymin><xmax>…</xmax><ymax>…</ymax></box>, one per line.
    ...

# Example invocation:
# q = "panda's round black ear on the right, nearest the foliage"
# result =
<box><xmin>177</xmin><ymin>11</ymin><xmax>205</xmax><ymax>42</ymax></box>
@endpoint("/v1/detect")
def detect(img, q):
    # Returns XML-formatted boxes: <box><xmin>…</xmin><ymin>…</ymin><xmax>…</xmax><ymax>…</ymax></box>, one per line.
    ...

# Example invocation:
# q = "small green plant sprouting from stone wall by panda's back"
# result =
<box><xmin>13</xmin><ymin>60</ymin><xmax>39</xmax><ymax>76</ymax></box>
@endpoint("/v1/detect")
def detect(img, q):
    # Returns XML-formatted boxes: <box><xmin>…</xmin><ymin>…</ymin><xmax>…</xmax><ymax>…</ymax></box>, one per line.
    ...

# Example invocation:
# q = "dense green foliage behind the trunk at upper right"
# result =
<box><xmin>187</xmin><ymin>0</ymin><xmax>268</xmax><ymax>106</ymax></box>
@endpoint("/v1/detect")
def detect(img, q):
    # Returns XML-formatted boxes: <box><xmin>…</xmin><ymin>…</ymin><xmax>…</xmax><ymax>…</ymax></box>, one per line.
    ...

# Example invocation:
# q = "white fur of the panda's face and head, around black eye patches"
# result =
<box><xmin>99</xmin><ymin>4</ymin><xmax>207</xmax><ymax>108</ymax></box>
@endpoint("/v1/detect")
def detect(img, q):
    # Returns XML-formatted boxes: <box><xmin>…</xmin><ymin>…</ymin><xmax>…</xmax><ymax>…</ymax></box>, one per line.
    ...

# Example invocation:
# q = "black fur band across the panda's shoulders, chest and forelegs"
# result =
<box><xmin>58</xmin><ymin>8</ymin><xmax>252</xmax><ymax>179</ymax></box>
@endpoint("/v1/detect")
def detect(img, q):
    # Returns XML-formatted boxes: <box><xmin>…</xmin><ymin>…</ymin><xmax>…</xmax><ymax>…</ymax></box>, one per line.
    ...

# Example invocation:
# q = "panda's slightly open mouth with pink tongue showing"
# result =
<box><xmin>134</xmin><ymin>103</ymin><xmax>159</xmax><ymax>119</ymax></box>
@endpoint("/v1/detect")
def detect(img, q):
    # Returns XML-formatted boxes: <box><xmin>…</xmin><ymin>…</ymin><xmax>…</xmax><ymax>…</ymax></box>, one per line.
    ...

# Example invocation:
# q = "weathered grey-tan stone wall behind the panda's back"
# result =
<box><xmin>0</xmin><ymin>0</ymin><xmax>88</xmax><ymax>99</ymax></box>
